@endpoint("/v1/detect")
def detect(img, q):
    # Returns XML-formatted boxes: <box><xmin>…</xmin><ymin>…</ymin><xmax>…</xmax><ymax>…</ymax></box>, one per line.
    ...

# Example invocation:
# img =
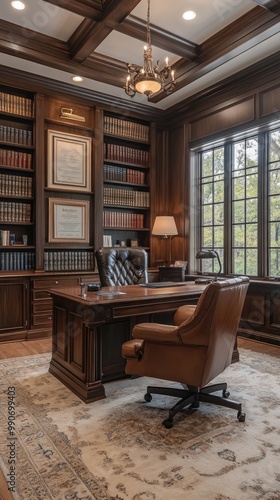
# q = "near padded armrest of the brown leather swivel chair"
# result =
<box><xmin>132</xmin><ymin>323</ymin><xmax>181</xmax><ymax>344</ymax></box>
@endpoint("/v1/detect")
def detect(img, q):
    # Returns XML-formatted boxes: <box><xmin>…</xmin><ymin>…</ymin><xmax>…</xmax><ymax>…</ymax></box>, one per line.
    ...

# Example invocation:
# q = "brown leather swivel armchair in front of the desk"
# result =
<box><xmin>122</xmin><ymin>276</ymin><xmax>249</xmax><ymax>428</ymax></box>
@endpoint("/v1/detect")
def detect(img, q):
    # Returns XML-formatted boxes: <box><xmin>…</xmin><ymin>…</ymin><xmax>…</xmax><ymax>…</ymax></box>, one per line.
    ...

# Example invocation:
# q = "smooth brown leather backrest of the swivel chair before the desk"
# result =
<box><xmin>178</xmin><ymin>276</ymin><xmax>249</xmax><ymax>385</ymax></box>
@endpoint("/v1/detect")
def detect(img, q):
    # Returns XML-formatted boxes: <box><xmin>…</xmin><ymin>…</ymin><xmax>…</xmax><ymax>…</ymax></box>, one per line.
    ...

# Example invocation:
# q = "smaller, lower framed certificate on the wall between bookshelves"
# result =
<box><xmin>48</xmin><ymin>198</ymin><xmax>89</xmax><ymax>243</ymax></box>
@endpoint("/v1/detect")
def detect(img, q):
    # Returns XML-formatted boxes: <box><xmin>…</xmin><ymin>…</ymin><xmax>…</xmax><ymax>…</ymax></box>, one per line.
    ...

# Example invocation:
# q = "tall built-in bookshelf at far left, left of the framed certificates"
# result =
<box><xmin>0</xmin><ymin>87</ymin><xmax>35</xmax><ymax>271</ymax></box>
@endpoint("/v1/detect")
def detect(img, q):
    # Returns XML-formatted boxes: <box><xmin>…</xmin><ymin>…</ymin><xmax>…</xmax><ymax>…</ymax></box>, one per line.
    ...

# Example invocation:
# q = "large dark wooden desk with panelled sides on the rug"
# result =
<box><xmin>49</xmin><ymin>282</ymin><xmax>232</xmax><ymax>403</ymax></box>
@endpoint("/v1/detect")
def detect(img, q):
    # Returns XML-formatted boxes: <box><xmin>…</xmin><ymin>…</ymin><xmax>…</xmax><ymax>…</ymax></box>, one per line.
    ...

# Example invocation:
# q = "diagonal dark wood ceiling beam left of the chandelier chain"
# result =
<box><xmin>69</xmin><ymin>0</ymin><xmax>140</xmax><ymax>62</ymax></box>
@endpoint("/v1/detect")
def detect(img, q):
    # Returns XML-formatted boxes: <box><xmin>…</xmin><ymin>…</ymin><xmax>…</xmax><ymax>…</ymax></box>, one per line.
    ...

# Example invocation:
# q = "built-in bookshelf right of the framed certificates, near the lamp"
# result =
<box><xmin>103</xmin><ymin>114</ymin><xmax>150</xmax><ymax>249</ymax></box>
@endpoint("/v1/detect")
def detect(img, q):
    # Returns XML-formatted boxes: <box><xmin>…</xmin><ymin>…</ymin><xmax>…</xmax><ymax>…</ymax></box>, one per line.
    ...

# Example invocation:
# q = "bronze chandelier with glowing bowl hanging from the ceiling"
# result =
<box><xmin>124</xmin><ymin>0</ymin><xmax>176</xmax><ymax>97</ymax></box>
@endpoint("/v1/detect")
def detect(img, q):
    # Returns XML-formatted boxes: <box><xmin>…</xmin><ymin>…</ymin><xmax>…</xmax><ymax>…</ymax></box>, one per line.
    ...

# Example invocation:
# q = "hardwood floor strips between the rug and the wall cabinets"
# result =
<box><xmin>0</xmin><ymin>337</ymin><xmax>280</xmax><ymax>360</ymax></box>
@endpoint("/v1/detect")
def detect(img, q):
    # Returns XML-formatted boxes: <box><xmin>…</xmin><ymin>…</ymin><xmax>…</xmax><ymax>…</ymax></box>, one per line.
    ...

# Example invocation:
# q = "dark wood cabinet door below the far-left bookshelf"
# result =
<box><xmin>0</xmin><ymin>277</ymin><xmax>29</xmax><ymax>342</ymax></box>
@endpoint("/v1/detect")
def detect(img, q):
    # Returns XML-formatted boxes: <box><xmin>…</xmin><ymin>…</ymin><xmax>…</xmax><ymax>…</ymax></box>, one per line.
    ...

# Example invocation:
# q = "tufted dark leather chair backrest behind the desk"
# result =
<box><xmin>95</xmin><ymin>247</ymin><xmax>148</xmax><ymax>286</ymax></box>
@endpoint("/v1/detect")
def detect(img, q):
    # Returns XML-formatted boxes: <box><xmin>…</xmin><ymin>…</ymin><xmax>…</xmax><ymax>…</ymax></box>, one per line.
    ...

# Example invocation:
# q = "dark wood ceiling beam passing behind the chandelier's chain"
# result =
<box><xmin>115</xmin><ymin>15</ymin><xmax>199</xmax><ymax>59</ymax></box>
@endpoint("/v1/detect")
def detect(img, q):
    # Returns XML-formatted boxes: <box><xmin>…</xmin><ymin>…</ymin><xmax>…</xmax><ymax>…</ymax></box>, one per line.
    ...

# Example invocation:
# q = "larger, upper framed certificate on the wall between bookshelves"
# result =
<box><xmin>47</xmin><ymin>130</ymin><xmax>92</xmax><ymax>192</ymax></box>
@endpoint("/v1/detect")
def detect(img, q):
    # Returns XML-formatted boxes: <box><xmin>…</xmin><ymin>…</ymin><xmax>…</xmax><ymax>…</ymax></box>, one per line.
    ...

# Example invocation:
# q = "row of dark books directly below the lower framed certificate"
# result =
<box><xmin>44</xmin><ymin>250</ymin><xmax>94</xmax><ymax>271</ymax></box>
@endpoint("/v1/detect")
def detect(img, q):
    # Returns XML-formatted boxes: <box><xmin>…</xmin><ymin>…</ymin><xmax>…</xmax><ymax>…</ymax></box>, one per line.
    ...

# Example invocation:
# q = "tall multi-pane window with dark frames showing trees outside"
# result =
<box><xmin>196</xmin><ymin>129</ymin><xmax>280</xmax><ymax>277</ymax></box>
